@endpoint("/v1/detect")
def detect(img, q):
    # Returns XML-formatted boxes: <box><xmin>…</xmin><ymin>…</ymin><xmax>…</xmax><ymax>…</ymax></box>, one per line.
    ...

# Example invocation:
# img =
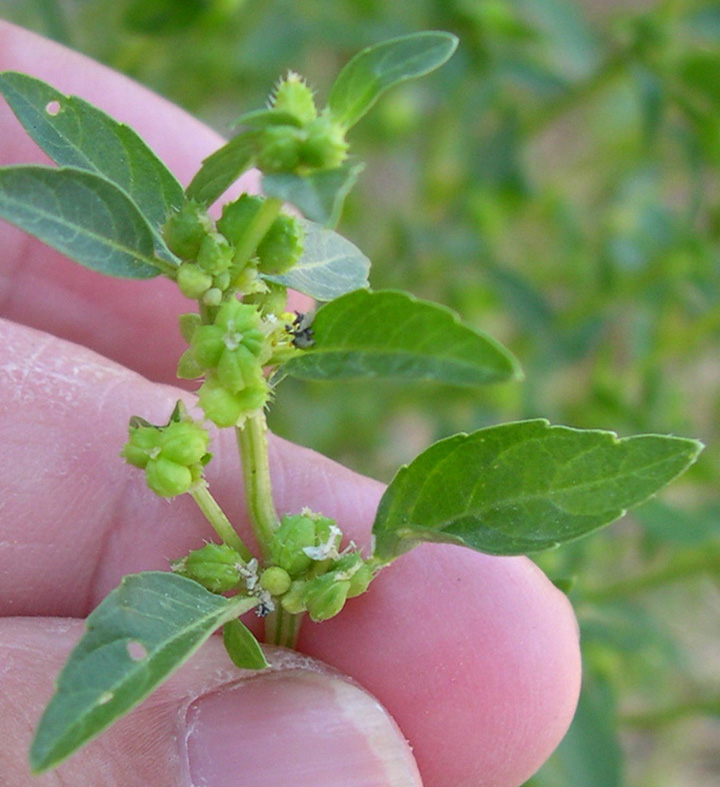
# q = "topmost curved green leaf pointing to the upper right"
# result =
<box><xmin>328</xmin><ymin>31</ymin><xmax>458</xmax><ymax>128</ymax></box>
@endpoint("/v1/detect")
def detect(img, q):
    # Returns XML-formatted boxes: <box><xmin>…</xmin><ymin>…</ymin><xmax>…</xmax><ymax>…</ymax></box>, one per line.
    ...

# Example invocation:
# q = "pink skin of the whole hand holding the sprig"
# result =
<box><xmin>0</xmin><ymin>21</ymin><xmax>580</xmax><ymax>787</ymax></box>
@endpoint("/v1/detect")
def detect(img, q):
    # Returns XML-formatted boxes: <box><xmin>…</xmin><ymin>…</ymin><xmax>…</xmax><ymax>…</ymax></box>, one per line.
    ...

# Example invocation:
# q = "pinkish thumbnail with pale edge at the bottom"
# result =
<box><xmin>186</xmin><ymin>669</ymin><xmax>422</xmax><ymax>787</ymax></box>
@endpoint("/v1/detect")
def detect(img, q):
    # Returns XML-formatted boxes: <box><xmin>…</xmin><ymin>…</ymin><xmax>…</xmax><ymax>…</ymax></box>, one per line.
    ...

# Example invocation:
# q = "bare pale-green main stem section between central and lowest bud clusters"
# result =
<box><xmin>235</xmin><ymin>410</ymin><xmax>279</xmax><ymax>557</ymax></box>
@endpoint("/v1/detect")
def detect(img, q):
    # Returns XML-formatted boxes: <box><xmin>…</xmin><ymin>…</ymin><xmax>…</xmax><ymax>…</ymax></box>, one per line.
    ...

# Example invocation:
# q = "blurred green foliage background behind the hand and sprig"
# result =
<box><xmin>0</xmin><ymin>0</ymin><xmax>720</xmax><ymax>787</ymax></box>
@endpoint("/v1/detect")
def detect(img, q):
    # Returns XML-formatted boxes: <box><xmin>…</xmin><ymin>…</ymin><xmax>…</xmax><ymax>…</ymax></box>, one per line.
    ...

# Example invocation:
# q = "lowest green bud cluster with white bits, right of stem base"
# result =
<box><xmin>261</xmin><ymin>510</ymin><xmax>373</xmax><ymax>622</ymax></box>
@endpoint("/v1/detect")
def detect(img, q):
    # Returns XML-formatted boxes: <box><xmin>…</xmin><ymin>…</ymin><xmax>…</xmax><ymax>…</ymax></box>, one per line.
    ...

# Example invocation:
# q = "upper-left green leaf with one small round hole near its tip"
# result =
<box><xmin>0</xmin><ymin>71</ymin><xmax>185</xmax><ymax>261</ymax></box>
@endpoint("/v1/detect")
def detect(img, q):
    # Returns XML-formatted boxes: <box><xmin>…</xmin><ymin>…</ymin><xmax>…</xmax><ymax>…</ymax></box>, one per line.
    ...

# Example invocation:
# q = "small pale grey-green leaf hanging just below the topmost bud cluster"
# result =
<box><xmin>262</xmin><ymin>161</ymin><xmax>365</xmax><ymax>227</ymax></box>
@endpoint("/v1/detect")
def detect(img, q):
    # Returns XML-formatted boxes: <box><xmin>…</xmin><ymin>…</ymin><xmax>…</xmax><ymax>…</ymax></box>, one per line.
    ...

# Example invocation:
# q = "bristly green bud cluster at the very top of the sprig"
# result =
<box><xmin>256</xmin><ymin>71</ymin><xmax>348</xmax><ymax>174</ymax></box>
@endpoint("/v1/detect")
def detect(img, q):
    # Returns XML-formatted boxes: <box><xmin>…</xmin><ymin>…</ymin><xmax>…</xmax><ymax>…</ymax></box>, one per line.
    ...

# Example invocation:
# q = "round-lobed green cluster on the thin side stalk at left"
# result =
<box><xmin>122</xmin><ymin>419</ymin><xmax>210</xmax><ymax>497</ymax></box>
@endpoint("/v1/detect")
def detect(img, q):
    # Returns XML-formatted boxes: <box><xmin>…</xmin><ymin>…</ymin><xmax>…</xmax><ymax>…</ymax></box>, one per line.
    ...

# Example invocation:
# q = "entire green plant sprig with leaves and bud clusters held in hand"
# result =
<box><xmin>0</xmin><ymin>32</ymin><xmax>701</xmax><ymax>773</ymax></box>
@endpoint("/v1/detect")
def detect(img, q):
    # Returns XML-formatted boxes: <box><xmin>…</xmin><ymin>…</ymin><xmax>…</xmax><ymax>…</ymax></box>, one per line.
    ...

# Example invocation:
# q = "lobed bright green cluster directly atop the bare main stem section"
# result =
<box><xmin>178</xmin><ymin>298</ymin><xmax>272</xmax><ymax>427</ymax></box>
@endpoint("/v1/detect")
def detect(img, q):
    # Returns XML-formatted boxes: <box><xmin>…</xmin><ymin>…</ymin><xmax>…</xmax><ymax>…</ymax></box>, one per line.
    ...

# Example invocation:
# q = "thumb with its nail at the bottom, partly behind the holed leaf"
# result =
<box><xmin>0</xmin><ymin>618</ymin><xmax>421</xmax><ymax>787</ymax></box>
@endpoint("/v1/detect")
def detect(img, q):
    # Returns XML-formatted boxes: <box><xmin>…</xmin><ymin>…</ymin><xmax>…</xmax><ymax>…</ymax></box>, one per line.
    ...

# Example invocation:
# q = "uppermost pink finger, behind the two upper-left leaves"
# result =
<box><xmin>0</xmin><ymin>20</ymin><xmax>274</xmax><ymax>382</ymax></box>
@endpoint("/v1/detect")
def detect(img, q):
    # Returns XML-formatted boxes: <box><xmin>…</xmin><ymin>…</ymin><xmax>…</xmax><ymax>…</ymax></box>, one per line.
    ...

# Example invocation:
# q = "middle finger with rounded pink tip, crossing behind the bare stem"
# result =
<box><xmin>0</xmin><ymin>324</ymin><xmax>580</xmax><ymax>787</ymax></box>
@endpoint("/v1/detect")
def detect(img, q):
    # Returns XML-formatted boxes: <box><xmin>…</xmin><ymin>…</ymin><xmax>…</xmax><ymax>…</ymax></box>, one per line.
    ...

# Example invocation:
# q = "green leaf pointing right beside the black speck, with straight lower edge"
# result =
<box><xmin>283</xmin><ymin>290</ymin><xmax>520</xmax><ymax>385</ymax></box>
